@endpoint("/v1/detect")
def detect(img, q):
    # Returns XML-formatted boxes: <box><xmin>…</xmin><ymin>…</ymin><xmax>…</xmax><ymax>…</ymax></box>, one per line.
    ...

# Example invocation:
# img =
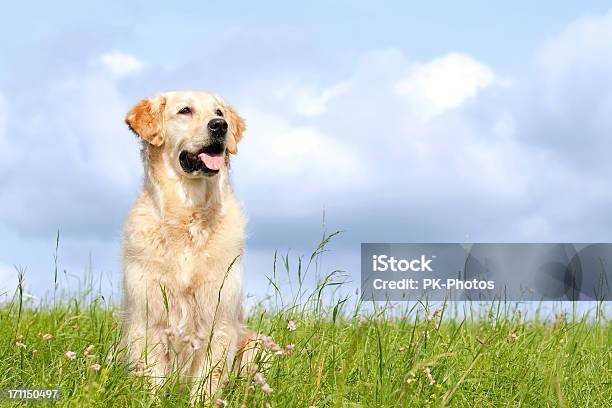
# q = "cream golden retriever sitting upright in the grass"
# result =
<box><xmin>123</xmin><ymin>91</ymin><xmax>256</xmax><ymax>403</ymax></box>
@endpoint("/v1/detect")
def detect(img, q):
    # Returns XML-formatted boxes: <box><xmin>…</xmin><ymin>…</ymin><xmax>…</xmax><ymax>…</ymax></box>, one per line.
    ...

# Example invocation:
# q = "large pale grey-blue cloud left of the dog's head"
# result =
<box><xmin>0</xmin><ymin>74</ymin><xmax>142</xmax><ymax>237</ymax></box>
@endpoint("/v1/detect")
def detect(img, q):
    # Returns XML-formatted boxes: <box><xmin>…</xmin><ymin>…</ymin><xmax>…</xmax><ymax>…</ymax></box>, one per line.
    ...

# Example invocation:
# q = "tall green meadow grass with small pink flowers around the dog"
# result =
<box><xmin>0</xmin><ymin>234</ymin><xmax>612</xmax><ymax>407</ymax></box>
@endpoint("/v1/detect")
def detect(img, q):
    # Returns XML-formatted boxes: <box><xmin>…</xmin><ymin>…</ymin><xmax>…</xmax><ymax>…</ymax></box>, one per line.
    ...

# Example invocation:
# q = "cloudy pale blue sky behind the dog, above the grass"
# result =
<box><xmin>0</xmin><ymin>1</ymin><xmax>612</xmax><ymax>296</ymax></box>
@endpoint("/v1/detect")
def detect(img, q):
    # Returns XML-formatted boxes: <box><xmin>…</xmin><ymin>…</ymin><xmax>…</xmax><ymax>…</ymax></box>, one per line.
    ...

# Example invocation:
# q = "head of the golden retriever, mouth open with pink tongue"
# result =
<box><xmin>125</xmin><ymin>91</ymin><xmax>244</xmax><ymax>178</ymax></box>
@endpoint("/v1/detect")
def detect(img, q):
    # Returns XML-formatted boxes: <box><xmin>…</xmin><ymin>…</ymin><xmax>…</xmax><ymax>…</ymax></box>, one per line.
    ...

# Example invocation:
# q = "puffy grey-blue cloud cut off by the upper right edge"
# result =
<box><xmin>512</xmin><ymin>11</ymin><xmax>612</xmax><ymax>175</ymax></box>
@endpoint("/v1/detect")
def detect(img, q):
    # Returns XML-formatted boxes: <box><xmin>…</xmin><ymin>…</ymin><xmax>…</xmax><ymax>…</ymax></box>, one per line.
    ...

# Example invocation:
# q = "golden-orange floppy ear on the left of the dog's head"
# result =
<box><xmin>125</xmin><ymin>95</ymin><xmax>166</xmax><ymax>146</ymax></box>
